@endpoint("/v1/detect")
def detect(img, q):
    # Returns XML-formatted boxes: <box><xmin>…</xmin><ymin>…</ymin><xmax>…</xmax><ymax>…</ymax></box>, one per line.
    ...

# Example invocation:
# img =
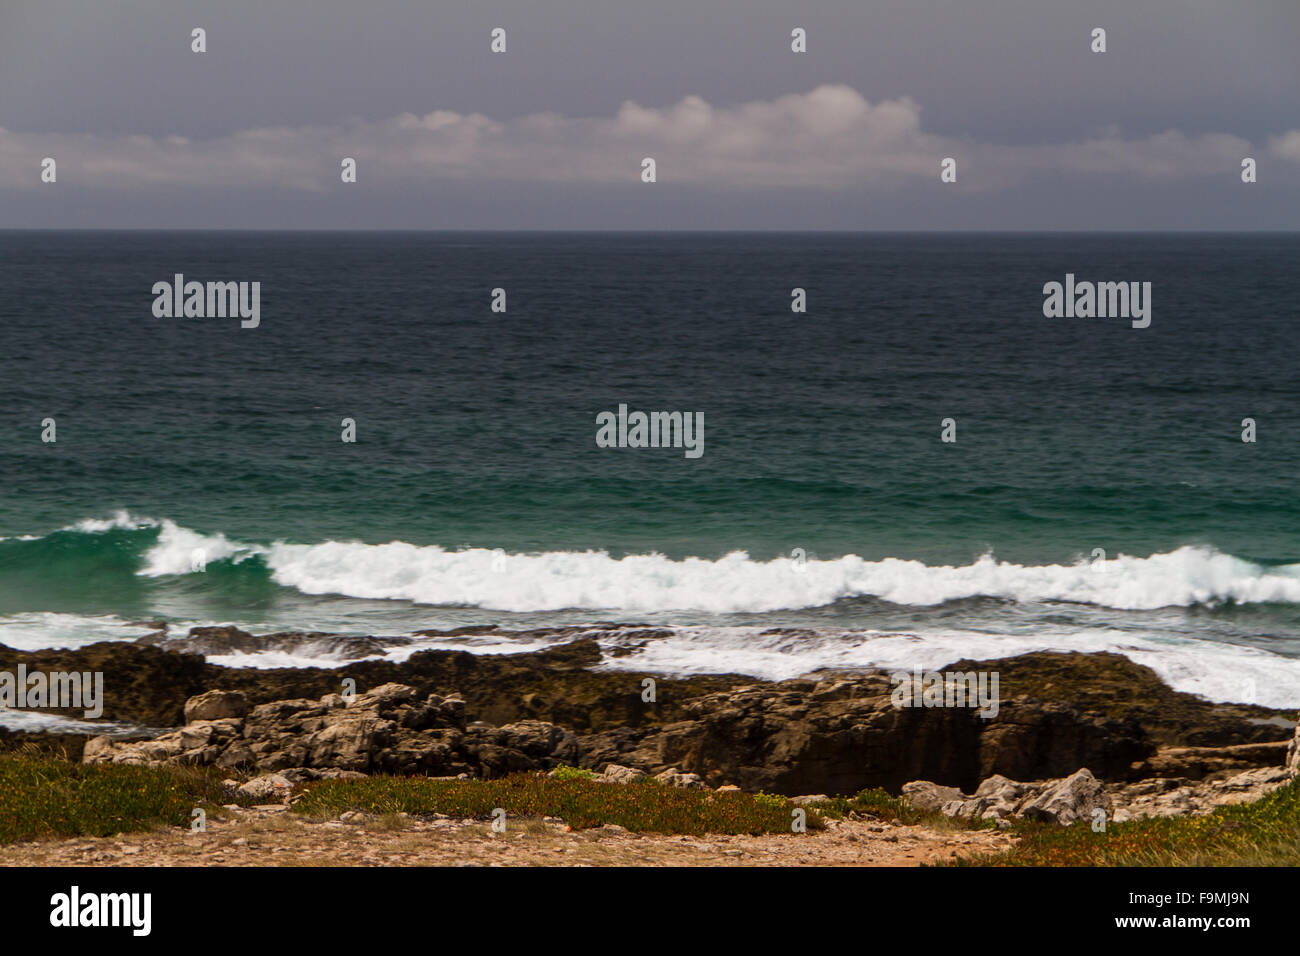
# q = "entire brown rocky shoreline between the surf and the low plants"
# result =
<box><xmin>0</xmin><ymin>627</ymin><xmax>1297</xmax><ymax>823</ymax></box>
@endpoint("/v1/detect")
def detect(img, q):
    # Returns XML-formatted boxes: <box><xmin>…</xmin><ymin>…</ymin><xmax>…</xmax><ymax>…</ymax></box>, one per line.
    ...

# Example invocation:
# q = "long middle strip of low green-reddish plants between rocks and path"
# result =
<box><xmin>293</xmin><ymin>771</ymin><xmax>823</xmax><ymax>835</ymax></box>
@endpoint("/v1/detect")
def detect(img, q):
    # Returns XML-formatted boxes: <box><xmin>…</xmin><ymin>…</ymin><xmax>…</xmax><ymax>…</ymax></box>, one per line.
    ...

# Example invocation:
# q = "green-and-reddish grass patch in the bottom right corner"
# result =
<box><xmin>958</xmin><ymin>780</ymin><xmax>1300</xmax><ymax>866</ymax></box>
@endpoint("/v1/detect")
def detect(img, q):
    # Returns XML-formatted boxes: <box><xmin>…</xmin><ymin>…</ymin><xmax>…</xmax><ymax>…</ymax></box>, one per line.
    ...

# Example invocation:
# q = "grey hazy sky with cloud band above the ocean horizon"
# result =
<box><xmin>0</xmin><ymin>0</ymin><xmax>1300</xmax><ymax>230</ymax></box>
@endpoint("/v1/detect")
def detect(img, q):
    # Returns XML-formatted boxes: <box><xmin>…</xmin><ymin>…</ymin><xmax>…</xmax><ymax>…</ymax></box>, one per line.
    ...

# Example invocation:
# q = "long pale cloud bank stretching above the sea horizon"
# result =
<box><xmin>0</xmin><ymin>85</ymin><xmax>1279</xmax><ymax>191</ymax></box>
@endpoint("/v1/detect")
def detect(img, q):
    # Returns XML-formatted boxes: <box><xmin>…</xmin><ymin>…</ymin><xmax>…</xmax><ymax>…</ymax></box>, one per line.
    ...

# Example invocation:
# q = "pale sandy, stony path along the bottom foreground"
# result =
<box><xmin>0</xmin><ymin>805</ymin><xmax>1011</xmax><ymax>866</ymax></box>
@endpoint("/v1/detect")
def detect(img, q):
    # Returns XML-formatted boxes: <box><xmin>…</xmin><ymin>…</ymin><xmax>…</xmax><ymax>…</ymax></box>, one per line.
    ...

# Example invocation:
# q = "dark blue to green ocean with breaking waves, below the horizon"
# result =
<box><xmin>0</xmin><ymin>232</ymin><xmax>1300</xmax><ymax>706</ymax></box>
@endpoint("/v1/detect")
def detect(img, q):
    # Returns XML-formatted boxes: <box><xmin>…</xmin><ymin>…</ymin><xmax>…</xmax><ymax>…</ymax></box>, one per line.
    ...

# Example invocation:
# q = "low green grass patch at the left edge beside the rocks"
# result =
<box><xmin>0</xmin><ymin>754</ymin><xmax>241</xmax><ymax>844</ymax></box>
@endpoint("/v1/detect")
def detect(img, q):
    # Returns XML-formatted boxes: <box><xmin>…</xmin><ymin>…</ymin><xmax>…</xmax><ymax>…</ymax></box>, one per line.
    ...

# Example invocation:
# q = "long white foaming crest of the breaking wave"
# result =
<box><xmin>258</xmin><ymin>541</ymin><xmax>1300</xmax><ymax>613</ymax></box>
